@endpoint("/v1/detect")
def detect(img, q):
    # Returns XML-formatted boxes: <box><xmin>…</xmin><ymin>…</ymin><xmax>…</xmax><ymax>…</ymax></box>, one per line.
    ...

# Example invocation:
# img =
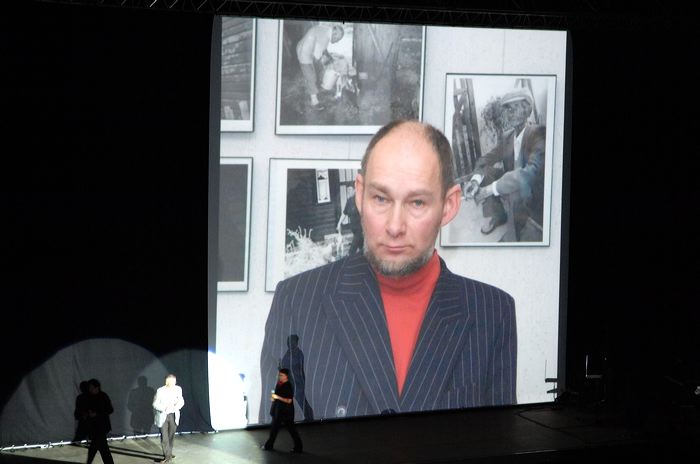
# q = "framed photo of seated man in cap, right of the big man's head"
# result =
<box><xmin>440</xmin><ymin>74</ymin><xmax>556</xmax><ymax>246</ymax></box>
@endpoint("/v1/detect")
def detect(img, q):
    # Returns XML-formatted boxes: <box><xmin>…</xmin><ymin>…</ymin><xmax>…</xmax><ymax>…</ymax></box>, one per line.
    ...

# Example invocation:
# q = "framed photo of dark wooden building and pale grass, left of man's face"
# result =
<box><xmin>265</xmin><ymin>158</ymin><xmax>363</xmax><ymax>291</ymax></box>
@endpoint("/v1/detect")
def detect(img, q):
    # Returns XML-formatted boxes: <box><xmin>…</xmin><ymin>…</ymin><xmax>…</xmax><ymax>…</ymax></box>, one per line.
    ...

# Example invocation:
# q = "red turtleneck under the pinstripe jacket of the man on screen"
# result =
<box><xmin>377</xmin><ymin>252</ymin><xmax>440</xmax><ymax>394</ymax></box>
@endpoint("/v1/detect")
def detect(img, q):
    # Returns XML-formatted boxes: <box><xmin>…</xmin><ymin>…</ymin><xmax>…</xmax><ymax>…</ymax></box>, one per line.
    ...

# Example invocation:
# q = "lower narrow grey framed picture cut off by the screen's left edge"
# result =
<box><xmin>217</xmin><ymin>158</ymin><xmax>253</xmax><ymax>292</ymax></box>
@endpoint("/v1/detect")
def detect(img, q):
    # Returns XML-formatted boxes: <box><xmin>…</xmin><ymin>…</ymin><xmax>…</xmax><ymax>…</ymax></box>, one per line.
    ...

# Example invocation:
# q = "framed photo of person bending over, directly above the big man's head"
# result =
<box><xmin>276</xmin><ymin>20</ymin><xmax>425</xmax><ymax>134</ymax></box>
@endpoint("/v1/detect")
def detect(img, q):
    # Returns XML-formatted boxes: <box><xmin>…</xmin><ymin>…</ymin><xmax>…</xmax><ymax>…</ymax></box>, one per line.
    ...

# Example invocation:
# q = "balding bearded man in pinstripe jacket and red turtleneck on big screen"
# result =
<box><xmin>260</xmin><ymin>120</ymin><xmax>517</xmax><ymax>423</ymax></box>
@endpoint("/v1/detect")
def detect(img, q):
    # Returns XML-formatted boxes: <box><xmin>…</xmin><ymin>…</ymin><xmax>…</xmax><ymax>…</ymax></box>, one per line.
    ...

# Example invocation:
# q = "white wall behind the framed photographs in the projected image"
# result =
<box><xmin>210</xmin><ymin>19</ymin><xmax>566</xmax><ymax>428</ymax></box>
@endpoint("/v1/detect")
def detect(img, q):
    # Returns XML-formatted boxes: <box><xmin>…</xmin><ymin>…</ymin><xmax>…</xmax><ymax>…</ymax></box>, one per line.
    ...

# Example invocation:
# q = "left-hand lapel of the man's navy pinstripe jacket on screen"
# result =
<box><xmin>323</xmin><ymin>256</ymin><xmax>399</xmax><ymax>412</ymax></box>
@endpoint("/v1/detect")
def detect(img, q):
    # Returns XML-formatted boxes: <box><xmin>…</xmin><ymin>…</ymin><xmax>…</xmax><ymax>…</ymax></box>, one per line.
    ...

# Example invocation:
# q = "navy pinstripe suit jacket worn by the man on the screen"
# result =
<box><xmin>259</xmin><ymin>255</ymin><xmax>517</xmax><ymax>423</ymax></box>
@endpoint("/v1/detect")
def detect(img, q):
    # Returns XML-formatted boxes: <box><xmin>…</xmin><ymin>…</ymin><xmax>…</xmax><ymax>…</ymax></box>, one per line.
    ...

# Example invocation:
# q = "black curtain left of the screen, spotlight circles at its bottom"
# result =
<box><xmin>0</xmin><ymin>2</ymin><xmax>213</xmax><ymax>446</ymax></box>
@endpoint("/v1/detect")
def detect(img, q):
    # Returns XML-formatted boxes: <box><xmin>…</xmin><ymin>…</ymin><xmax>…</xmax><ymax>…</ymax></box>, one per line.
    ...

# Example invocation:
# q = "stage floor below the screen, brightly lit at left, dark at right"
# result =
<box><xmin>0</xmin><ymin>403</ymin><xmax>700</xmax><ymax>464</ymax></box>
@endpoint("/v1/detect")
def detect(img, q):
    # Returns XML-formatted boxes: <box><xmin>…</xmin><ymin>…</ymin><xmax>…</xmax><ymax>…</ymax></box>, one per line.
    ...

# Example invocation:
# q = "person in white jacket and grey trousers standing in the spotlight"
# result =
<box><xmin>153</xmin><ymin>374</ymin><xmax>185</xmax><ymax>463</ymax></box>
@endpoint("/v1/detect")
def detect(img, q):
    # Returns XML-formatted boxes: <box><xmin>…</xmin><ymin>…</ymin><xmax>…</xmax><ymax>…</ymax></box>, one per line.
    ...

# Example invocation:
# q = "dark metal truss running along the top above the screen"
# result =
<box><xmin>34</xmin><ymin>0</ymin><xmax>688</xmax><ymax>30</ymax></box>
